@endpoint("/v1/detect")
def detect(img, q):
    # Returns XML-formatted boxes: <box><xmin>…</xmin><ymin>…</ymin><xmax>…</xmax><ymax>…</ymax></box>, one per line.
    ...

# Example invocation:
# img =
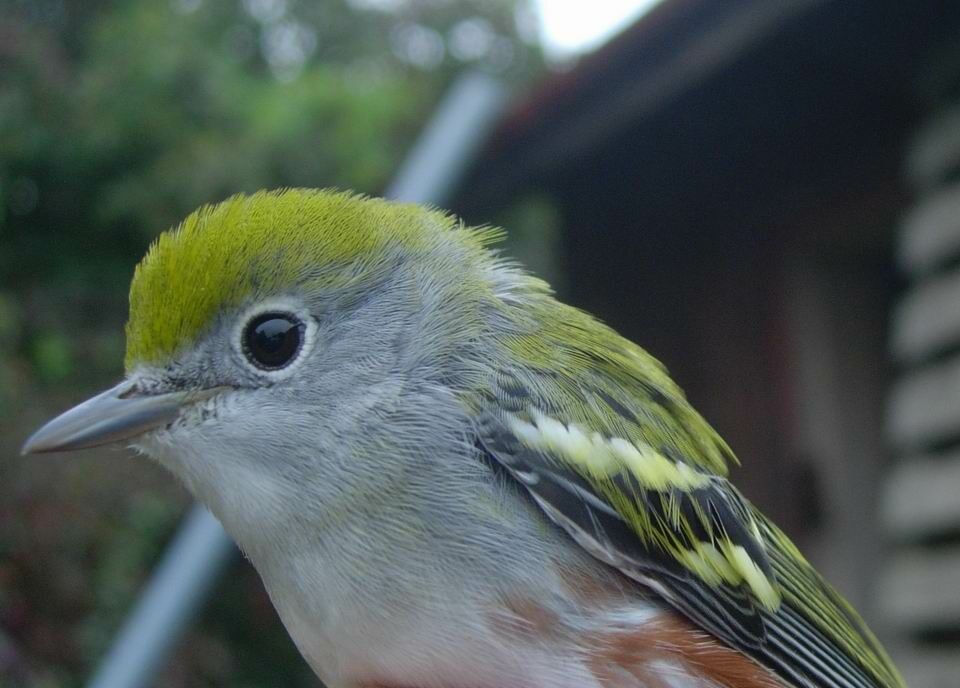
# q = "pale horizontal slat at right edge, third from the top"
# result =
<box><xmin>892</xmin><ymin>268</ymin><xmax>960</xmax><ymax>362</ymax></box>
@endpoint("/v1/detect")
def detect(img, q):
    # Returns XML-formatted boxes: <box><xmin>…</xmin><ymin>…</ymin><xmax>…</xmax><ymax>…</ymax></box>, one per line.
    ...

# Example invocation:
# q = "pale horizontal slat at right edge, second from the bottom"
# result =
<box><xmin>877</xmin><ymin>546</ymin><xmax>960</xmax><ymax>632</ymax></box>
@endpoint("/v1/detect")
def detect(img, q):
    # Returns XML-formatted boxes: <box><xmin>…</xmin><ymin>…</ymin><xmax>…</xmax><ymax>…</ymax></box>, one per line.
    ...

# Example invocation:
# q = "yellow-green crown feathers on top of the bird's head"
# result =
<box><xmin>125</xmin><ymin>189</ymin><xmax>499</xmax><ymax>370</ymax></box>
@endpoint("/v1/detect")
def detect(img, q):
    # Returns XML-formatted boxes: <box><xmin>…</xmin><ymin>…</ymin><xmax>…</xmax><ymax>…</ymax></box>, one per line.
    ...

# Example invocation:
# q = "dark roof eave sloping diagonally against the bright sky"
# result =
<box><xmin>454</xmin><ymin>0</ymin><xmax>828</xmax><ymax>212</ymax></box>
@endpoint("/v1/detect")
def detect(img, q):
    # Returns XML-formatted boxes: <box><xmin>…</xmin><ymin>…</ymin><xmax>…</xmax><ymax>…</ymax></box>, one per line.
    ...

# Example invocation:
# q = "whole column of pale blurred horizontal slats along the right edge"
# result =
<box><xmin>878</xmin><ymin>102</ymin><xmax>960</xmax><ymax>688</ymax></box>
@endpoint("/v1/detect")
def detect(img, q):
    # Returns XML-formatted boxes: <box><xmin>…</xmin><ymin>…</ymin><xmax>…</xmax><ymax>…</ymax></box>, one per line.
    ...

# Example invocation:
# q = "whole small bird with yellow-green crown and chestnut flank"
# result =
<box><xmin>23</xmin><ymin>189</ymin><xmax>905</xmax><ymax>688</ymax></box>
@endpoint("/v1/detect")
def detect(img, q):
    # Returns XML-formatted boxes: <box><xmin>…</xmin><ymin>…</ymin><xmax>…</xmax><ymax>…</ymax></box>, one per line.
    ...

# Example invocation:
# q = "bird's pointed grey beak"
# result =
<box><xmin>21</xmin><ymin>380</ymin><xmax>224</xmax><ymax>454</ymax></box>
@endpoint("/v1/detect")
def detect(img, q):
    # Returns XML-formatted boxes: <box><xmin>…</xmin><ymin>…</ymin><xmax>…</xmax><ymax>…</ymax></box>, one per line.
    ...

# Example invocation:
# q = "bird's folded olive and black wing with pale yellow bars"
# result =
<box><xmin>477</xmin><ymin>309</ymin><xmax>904</xmax><ymax>688</ymax></box>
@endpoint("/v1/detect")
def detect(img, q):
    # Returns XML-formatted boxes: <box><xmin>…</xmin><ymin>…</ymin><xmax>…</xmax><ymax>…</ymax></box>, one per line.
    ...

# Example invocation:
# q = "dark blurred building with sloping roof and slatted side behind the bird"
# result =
<box><xmin>452</xmin><ymin>0</ymin><xmax>960</xmax><ymax>688</ymax></box>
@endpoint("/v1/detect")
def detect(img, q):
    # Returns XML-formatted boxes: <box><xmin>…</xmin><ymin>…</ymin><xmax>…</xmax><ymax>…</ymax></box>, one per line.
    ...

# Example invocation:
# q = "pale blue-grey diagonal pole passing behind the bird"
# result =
<box><xmin>88</xmin><ymin>72</ymin><xmax>506</xmax><ymax>688</ymax></box>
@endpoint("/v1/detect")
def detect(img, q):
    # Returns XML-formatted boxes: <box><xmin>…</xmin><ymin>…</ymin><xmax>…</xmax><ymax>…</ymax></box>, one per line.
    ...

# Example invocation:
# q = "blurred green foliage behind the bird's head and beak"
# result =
<box><xmin>0</xmin><ymin>0</ymin><xmax>542</xmax><ymax>687</ymax></box>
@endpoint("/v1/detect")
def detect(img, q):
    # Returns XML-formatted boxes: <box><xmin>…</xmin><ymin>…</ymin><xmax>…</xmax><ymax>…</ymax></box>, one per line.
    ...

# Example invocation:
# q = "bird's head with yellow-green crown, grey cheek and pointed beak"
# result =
<box><xmin>18</xmin><ymin>190</ymin><xmax>506</xmax><ymax>528</ymax></box>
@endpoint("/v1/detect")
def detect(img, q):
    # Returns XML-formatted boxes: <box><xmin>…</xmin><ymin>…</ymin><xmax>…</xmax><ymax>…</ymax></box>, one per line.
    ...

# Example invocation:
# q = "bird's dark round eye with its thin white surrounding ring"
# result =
<box><xmin>232</xmin><ymin>298</ymin><xmax>317</xmax><ymax>380</ymax></box>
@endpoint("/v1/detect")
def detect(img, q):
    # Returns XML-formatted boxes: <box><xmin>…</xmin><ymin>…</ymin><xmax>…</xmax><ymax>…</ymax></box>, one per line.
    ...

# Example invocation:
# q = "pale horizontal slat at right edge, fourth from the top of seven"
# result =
<box><xmin>887</xmin><ymin>356</ymin><xmax>960</xmax><ymax>450</ymax></box>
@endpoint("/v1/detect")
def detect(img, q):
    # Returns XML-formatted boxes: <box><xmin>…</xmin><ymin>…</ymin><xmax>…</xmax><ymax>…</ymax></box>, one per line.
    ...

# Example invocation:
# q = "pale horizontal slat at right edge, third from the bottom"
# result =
<box><xmin>882</xmin><ymin>452</ymin><xmax>960</xmax><ymax>540</ymax></box>
